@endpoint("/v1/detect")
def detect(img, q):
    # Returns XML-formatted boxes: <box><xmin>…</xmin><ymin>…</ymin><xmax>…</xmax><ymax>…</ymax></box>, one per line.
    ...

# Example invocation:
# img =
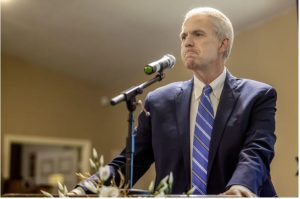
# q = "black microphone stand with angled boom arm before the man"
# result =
<box><xmin>110</xmin><ymin>72</ymin><xmax>164</xmax><ymax>189</ymax></box>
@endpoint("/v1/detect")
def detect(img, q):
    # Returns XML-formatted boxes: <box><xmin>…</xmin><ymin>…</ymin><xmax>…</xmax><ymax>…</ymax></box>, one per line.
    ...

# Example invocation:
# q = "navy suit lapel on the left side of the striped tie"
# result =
<box><xmin>175</xmin><ymin>80</ymin><xmax>193</xmax><ymax>187</ymax></box>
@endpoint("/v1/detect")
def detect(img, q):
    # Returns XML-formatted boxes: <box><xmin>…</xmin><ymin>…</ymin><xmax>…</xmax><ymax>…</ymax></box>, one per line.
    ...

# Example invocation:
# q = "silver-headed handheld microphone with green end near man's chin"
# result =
<box><xmin>144</xmin><ymin>54</ymin><xmax>176</xmax><ymax>75</ymax></box>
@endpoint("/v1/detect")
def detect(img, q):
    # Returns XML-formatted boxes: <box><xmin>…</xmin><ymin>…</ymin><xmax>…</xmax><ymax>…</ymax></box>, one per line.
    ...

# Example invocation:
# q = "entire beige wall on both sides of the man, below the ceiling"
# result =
<box><xmin>1</xmin><ymin>7</ymin><xmax>298</xmax><ymax>196</ymax></box>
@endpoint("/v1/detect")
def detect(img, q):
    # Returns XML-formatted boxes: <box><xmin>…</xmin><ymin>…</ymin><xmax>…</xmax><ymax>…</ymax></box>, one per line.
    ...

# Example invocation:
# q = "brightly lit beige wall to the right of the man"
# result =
<box><xmin>227</xmin><ymin>9</ymin><xmax>298</xmax><ymax>196</ymax></box>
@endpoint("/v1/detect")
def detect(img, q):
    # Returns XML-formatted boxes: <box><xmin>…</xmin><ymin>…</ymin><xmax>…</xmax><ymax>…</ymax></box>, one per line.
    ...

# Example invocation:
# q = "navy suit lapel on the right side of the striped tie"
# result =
<box><xmin>207</xmin><ymin>71</ymin><xmax>239</xmax><ymax>178</ymax></box>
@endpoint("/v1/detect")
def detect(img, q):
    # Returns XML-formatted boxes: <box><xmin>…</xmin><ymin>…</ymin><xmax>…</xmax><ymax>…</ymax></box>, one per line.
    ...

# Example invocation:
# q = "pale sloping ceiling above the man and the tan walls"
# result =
<box><xmin>1</xmin><ymin>0</ymin><xmax>296</xmax><ymax>88</ymax></box>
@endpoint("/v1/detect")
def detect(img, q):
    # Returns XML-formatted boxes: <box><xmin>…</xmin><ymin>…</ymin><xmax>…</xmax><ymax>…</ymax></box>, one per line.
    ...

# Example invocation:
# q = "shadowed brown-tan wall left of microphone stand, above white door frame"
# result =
<box><xmin>1</xmin><ymin>56</ymin><xmax>123</xmax><ymax>161</ymax></box>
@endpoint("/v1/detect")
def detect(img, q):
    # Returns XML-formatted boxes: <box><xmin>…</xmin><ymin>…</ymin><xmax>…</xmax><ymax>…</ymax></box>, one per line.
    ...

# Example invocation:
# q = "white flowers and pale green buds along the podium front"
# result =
<box><xmin>41</xmin><ymin>149</ymin><xmax>194</xmax><ymax>197</ymax></box>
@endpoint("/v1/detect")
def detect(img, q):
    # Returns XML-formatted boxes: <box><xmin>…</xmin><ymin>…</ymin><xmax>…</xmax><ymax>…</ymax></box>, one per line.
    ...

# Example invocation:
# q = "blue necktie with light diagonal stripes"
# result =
<box><xmin>192</xmin><ymin>85</ymin><xmax>214</xmax><ymax>195</ymax></box>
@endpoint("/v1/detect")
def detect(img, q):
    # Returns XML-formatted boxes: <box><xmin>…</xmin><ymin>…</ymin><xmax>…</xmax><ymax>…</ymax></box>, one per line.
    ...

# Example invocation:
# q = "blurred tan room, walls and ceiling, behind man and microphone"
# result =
<box><xmin>1</xmin><ymin>0</ymin><xmax>298</xmax><ymax>197</ymax></box>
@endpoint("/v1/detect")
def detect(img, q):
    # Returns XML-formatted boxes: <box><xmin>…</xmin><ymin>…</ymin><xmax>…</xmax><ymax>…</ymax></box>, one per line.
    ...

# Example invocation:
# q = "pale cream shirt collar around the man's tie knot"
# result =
<box><xmin>194</xmin><ymin>67</ymin><xmax>227</xmax><ymax>100</ymax></box>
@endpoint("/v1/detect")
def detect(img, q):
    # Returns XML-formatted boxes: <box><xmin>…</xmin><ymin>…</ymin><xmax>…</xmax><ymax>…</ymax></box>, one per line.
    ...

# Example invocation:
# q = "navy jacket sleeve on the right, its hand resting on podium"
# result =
<box><xmin>227</xmin><ymin>88</ymin><xmax>276</xmax><ymax>194</ymax></box>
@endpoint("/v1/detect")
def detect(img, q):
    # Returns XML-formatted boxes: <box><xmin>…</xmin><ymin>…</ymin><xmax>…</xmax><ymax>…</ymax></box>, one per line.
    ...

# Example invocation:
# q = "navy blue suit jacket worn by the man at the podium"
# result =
<box><xmin>80</xmin><ymin>72</ymin><xmax>276</xmax><ymax>196</ymax></box>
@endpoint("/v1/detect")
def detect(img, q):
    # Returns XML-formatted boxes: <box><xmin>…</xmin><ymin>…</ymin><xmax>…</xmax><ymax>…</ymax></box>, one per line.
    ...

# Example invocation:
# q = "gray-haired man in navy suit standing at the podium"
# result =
<box><xmin>72</xmin><ymin>7</ymin><xmax>276</xmax><ymax>197</ymax></box>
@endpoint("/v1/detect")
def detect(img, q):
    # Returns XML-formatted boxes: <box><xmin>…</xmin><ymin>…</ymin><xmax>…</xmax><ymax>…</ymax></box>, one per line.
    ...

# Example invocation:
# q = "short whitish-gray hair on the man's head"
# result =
<box><xmin>183</xmin><ymin>7</ymin><xmax>234</xmax><ymax>59</ymax></box>
